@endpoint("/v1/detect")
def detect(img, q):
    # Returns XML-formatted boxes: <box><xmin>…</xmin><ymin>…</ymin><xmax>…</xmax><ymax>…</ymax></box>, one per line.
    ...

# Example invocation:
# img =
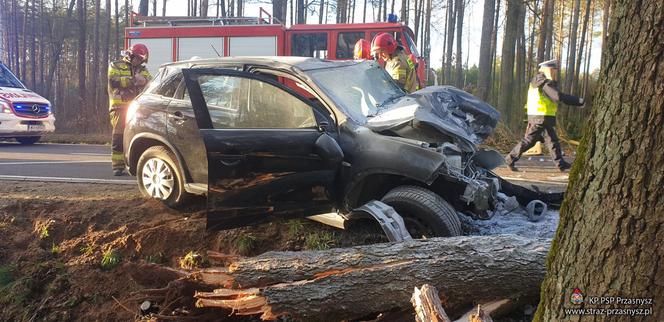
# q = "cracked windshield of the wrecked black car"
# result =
<box><xmin>307</xmin><ymin>61</ymin><xmax>406</xmax><ymax>124</ymax></box>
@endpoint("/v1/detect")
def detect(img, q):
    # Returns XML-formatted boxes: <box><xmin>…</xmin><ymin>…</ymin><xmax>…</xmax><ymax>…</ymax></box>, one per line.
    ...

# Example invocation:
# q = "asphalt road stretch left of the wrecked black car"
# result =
<box><xmin>0</xmin><ymin>142</ymin><xmax>135</xmax><ymax>183</ymax></box>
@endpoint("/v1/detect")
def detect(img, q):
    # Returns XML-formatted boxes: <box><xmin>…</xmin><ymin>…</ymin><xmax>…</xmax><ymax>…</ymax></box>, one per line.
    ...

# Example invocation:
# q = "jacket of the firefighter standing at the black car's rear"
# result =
<box><xmin>108</xmin><ymin>60</ymin><xmax>152</xmax><ymax>111</ymax></box>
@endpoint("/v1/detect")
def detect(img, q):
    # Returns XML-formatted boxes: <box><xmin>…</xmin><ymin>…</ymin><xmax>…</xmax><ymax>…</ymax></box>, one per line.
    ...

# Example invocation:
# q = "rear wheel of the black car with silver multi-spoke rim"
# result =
<box><xmin>136</xmin><ymin>146</ymin><xmax>191</xmax><ymax>208</ymax></box>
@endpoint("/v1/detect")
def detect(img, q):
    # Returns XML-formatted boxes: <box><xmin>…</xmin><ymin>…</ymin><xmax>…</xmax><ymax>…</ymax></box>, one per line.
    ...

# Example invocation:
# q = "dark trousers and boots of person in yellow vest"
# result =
<box><xmin>509</xmin><ymin>116</ymin><xmax>565</xmax><ymax>168</ymax></box>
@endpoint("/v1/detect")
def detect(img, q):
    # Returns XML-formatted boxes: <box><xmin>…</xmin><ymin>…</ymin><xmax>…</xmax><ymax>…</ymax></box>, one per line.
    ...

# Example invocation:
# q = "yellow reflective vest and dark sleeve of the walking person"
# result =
<box><xmin>526</xmin><ymin>73</ymin><xmax>583</xmax><ymax>116</ymax></box>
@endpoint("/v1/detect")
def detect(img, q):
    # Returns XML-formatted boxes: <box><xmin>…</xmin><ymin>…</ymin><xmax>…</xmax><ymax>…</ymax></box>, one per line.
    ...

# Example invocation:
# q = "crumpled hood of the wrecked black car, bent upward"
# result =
<box><xmin>366</xmin><ymin>86</ymin><xmax>500</xmax><ymax>144</ymax></box>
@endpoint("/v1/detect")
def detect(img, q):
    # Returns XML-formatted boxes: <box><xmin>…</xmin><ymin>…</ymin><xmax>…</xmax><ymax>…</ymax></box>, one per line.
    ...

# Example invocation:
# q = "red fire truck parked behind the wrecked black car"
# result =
<box><xmin>125</xmin><ymin>8</ymin><xmax>426</xmax><ymax>87</ymax></box>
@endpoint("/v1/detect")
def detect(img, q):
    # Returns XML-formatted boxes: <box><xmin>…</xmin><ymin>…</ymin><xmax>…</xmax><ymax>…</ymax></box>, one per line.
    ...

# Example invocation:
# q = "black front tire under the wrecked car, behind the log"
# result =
<box><xmin>382</xmin><ymin>186</ymin><xmax>462</xmax><ymax>238</ymax></box>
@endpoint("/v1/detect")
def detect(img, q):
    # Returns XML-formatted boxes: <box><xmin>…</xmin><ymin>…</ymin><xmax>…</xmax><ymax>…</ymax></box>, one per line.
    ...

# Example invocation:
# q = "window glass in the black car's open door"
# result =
<box><xmin>198</xmin><ymin>75</ymin><xmax>316</xmax><ymax>129</ymax></box>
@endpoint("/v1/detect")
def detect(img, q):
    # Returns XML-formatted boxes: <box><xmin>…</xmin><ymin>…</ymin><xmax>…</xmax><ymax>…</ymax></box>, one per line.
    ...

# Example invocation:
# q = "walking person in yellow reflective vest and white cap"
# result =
<box><xmin>505</xmin><ymin>59</ymin><xmax>583</xmax><ymax>172</ymax></box>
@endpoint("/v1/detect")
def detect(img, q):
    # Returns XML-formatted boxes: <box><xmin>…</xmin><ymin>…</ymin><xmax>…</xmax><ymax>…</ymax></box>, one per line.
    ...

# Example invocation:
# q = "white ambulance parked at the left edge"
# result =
<box><xmin>0</xmin><ymin>62</ymin><xmax>55</xmax><ymax>144</ymax></box>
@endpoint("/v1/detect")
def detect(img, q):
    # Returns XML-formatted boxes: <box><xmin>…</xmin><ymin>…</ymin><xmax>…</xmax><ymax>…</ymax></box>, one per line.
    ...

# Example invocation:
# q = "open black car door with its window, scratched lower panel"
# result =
<box><xmin>183</xmin><ymin>68</ymin><xmax>343</xmax><ymax>229</ymax></box>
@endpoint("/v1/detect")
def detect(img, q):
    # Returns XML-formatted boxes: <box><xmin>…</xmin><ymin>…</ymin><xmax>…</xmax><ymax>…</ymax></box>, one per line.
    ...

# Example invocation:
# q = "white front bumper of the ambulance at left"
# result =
<box><xmin>0</xmin><ymin>113</ymin><xmax>55</xmax><ymax>138</ymax></box>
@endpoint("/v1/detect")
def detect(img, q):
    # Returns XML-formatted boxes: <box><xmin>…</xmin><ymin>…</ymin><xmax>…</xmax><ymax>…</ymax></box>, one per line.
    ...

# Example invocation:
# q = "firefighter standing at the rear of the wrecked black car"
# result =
<box><xmin>108</xmin><ymin>44</ymin><xmax>152</xmax><ymax>176</ymax></box>
